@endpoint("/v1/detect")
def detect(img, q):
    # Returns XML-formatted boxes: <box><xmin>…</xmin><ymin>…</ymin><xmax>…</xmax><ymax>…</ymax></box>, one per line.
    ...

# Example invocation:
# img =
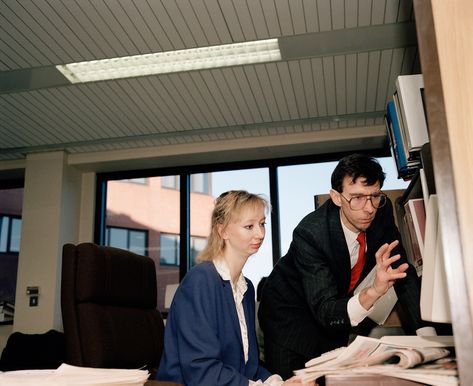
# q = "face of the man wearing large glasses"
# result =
<box><xmin>330</xmin><ymin>177</ymin><xmax>380</xmax><ymax>233</ymax></box>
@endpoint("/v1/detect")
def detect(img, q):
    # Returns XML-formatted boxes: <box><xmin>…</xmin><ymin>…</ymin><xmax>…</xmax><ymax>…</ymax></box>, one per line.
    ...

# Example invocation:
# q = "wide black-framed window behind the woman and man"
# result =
<box><xmin>96</xmin><ymin>151</ymin><xmax>407</xmax><ymax>312</ymax></box>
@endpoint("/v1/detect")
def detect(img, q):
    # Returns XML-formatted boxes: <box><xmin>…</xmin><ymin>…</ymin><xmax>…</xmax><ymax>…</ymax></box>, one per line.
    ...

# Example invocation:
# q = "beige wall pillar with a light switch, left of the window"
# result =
<box><xmin>13</xmin><ymin>152</ymin><xmax>82</xmax><ymax>333</ymax></box>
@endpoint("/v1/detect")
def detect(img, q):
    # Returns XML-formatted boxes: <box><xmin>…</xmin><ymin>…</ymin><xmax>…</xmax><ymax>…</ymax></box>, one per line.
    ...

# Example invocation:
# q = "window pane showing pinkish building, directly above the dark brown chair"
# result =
<box><xmin>106</xmin><ymin>175</ymin><xmax>180</xmax><ymax>311</ymax></box>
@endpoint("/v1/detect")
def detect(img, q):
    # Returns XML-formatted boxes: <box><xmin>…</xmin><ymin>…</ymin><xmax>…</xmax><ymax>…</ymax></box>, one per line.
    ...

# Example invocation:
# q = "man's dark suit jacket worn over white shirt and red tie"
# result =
<box><xmin>259</xmin><ymin>200</ymin><xmax>424</xmax><ymax>358</ymax></box>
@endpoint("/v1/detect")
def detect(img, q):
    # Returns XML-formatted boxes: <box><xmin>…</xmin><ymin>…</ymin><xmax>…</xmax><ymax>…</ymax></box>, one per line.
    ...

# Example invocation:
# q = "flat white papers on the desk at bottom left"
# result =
<box><xmin>0</xmin><ymin>363</ymin><xmax>149</xmax><ymax>386</ymax></box>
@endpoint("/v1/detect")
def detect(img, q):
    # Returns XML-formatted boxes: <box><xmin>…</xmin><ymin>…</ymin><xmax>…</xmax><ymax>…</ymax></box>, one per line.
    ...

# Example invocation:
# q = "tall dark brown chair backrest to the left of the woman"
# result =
<box><xmin>61</xmin><ymin>243</ymin><xmax>164</xmax><ymax>371</ymax></box>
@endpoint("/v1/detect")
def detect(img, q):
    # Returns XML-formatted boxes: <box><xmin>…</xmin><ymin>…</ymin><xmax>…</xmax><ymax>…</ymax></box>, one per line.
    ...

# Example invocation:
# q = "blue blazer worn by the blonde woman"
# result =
<box><xmin>156</xmin><ymin>262</ymin><xmax>271</xmax><ymax>386</ymax></box>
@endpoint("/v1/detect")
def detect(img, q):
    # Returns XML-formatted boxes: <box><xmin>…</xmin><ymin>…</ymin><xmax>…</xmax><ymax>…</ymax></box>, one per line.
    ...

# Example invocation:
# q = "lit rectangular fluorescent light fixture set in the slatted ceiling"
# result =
<box><xmin>56</xmin><ymin>39</ymin><xmax>281</xmax><ymax>83</ymax></box>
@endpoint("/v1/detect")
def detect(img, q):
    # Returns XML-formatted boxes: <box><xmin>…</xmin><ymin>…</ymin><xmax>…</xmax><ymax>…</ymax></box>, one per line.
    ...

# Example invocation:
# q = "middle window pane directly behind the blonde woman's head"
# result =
<box><xmin>190</xmin><ymin>168</ymin><xmax>273</xmax><ymax>294</ymax></box>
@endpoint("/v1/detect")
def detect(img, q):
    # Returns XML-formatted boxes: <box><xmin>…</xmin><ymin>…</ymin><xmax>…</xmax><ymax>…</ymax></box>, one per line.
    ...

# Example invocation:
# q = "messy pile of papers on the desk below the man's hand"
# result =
<box><xmin>295</xmin><ymin>335</ymin><xmax>459</xmax><ymax>386</ymax></box>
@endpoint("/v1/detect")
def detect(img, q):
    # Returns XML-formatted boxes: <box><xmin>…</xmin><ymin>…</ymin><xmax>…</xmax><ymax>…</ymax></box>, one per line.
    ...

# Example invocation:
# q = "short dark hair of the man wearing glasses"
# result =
<box><xmin>332</xmin><ymin>153</ymin><xmax>385</xmax><ymax>193</ymax></box>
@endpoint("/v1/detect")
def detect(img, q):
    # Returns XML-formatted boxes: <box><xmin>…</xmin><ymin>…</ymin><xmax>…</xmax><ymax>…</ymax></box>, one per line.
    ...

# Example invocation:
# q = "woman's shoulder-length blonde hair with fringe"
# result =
<box><xmin>197</xmin><ymin>190</ymin><xmax>270</xmax><ymax>262</ymax></box>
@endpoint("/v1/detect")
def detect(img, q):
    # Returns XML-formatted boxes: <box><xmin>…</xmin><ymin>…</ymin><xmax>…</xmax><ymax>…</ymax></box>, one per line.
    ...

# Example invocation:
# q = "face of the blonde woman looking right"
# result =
<box><xmin>222</xmin><ymin>206</ymin><xmax>266</xmax><ymax>257</ymax></box>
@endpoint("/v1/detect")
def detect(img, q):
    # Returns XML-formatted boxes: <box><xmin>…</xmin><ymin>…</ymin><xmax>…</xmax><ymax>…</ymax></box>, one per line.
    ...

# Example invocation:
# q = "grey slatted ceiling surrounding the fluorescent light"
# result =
<box><xmin>0</xmin><ymin>0</ymin><xmax>420</xmax><ymax>169</ymax></box>
